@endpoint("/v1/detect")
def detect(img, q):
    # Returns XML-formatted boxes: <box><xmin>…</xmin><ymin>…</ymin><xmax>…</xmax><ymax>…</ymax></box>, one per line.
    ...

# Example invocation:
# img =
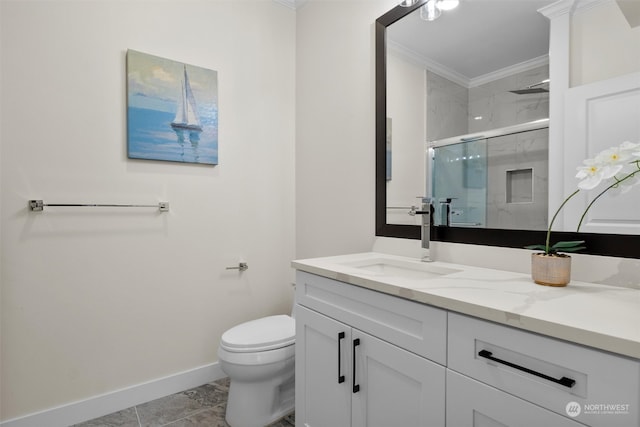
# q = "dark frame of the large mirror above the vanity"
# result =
<box><xmin>375</xmin><ymin>0</ymin><xmax>640</xmax><ymax>258</ymax></box>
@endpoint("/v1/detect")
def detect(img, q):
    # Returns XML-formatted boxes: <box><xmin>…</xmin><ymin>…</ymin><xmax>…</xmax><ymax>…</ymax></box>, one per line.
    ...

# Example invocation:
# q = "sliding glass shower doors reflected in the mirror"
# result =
<box><xmin>429</xmin><ymin>121</ymin><xmax>549</xmax><ymax>230</ymax></box>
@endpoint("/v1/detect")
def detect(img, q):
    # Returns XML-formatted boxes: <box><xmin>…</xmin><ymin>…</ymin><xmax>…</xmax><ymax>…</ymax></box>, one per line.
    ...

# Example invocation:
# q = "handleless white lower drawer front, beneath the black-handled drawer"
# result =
<box><xmin>447</xmin><ymin>369</ymin><xmax>584</xmax><ymax>427</ymax></box>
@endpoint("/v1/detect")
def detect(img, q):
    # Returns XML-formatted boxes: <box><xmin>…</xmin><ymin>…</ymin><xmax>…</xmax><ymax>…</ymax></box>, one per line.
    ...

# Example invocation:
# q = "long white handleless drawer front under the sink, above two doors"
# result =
<box><xmin>296</xmin><ymin>271</ymin><xmax>447</xmax><ymax>365</ymax></box>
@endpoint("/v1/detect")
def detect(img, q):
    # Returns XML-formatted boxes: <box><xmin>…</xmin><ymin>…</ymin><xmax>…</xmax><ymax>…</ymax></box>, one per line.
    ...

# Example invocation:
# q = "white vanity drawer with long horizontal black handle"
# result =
<box><xmin>447</xmin><ymin>313</ymin><xmax>640</xmax><ymax>427</ymax></box>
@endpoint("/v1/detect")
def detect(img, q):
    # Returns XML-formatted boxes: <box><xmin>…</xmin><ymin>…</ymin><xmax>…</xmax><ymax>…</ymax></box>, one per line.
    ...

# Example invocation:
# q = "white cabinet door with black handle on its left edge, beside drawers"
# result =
<box><xmin>350</xmin><ymin>329</ymin><xmax>445</xmax><ymax>427</ymax></box>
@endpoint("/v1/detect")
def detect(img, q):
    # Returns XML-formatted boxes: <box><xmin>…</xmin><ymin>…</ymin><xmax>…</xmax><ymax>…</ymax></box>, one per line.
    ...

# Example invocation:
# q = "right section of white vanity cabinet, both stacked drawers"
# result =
<box><xmin>447</xmin><ymin>312</ymin><xmax>640</xmax><ymax>427</ymax></box>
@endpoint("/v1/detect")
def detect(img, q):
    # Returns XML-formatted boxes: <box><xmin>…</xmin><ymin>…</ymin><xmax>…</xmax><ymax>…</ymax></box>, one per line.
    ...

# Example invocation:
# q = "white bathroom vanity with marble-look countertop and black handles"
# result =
<box><xmin>292</xmin><ymin>253</ymin><xmax>640</xmax><ymax>427</ymax></box>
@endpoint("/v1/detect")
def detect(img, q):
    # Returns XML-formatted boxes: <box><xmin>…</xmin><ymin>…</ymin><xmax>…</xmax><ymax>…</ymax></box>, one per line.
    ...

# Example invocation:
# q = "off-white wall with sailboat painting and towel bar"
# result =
<box><xmin>0</xmin><ymin>0</ymin><xmax>296</xmax><ymax>420</ymax></box>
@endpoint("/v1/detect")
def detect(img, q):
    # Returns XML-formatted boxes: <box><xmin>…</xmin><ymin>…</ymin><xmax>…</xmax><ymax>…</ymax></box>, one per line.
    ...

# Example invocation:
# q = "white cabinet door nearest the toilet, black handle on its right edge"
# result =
<box><xmin>295</xmin><ymin>305</ymin><xmax>352</xmax><ymax>427</ymax></box>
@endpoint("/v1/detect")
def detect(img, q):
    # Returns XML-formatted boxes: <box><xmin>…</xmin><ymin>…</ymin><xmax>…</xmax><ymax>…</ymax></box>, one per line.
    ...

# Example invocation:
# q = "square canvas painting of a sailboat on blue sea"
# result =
<box><xmin>127</xmin><ymin>49</ymin><xmax>218</xmax><ymax>165</ymax></box>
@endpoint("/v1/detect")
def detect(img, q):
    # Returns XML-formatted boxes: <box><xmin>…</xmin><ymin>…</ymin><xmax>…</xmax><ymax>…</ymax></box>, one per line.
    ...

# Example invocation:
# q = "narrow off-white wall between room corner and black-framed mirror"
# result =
<box><xmin>296</xmin><ymin>0</ymin><xmax>396</xmax><ymax>258</ymax></box>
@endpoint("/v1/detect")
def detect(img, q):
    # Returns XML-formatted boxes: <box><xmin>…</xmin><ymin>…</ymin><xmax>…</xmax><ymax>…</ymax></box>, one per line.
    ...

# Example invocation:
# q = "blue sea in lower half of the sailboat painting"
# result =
<box><xmin>127</xmin><ymin>106</ymin><xmax>218</xmax><ymax>165</ymax></box>
